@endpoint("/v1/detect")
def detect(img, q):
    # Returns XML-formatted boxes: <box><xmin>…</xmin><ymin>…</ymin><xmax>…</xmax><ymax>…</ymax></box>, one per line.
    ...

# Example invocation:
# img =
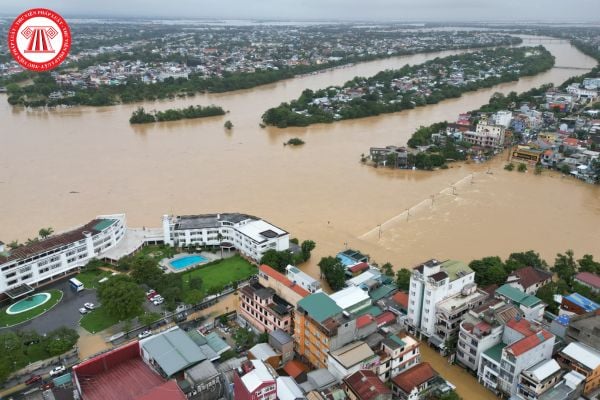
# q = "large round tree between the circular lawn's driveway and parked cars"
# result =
<box><xmin>98</xmin><ymin>275</ymin><xmax>146</xmax><ymax>321</ymax></box>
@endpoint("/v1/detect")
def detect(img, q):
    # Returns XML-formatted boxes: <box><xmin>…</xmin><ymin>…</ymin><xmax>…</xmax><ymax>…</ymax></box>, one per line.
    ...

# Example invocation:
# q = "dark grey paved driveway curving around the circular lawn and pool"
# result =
<box><xmin>0</xmin><ymin>279</ymin><xmax>98</xmax><ymax>334</ymax></box>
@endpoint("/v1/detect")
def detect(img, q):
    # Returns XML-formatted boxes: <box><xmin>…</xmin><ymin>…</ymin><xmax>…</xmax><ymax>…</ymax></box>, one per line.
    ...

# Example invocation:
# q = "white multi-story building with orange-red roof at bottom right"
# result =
<box><xmin>478</xmin><ymin>317</ymin><xmax>555</xmax><ymax>396</ymax></box>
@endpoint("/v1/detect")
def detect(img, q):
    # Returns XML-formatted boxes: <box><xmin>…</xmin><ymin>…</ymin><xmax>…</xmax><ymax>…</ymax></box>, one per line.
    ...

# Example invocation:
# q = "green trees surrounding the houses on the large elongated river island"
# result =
<box><xmin>262</xmin><ymin>46</ymin><xmax>554</xmax><ymax>128</ymax></box>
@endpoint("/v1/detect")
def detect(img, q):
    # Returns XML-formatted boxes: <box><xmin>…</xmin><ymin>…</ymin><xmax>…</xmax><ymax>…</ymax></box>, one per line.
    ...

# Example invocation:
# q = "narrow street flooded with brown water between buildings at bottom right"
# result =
<box><xmin>419</xmin><ymin>342</ymin><xmax>498</xmax><ymax>400</ymax></box>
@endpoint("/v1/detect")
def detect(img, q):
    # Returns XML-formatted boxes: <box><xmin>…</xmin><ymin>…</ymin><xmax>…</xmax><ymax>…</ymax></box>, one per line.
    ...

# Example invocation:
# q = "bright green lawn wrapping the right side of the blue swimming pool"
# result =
<box><xmin>181</xmin><ymin>255</ymin><xmax>257</xmax><ymax>292</ymax></box>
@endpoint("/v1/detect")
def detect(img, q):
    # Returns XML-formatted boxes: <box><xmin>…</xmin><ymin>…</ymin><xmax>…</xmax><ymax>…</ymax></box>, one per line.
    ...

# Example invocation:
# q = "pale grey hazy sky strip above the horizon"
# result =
<box><xmin>0</xmin><ymin>0</ymin><xmax>600</xmax><ymax>22</ymax></box>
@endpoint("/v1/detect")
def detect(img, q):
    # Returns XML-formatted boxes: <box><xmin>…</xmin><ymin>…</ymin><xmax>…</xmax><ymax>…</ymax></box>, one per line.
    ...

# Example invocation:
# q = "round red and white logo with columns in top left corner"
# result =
<box><xmin>8</xmin><ymin>8</ymin><xmax>71</xmax><ymax>71</ymax></box>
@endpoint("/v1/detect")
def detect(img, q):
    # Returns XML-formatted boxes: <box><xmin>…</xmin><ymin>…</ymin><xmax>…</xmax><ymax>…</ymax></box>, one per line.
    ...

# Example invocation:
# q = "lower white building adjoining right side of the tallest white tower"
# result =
<box><xmin>429</xmin><ymin>283</ymin><xmax>488</xmax><ymax>354</ymax></box>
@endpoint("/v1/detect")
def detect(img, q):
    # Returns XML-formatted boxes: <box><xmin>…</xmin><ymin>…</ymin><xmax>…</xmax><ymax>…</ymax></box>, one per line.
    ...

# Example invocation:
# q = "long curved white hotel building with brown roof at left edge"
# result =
<box><xmin>0</xmin><ymin>214</ymin><xmax>127</xmax><ymax>297</ymax></box>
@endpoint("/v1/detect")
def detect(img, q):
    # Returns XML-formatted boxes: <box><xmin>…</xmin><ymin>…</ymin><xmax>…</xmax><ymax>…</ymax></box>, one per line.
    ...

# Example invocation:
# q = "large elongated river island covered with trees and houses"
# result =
<box><xmin>262</xmin><ymin>46</ymin><xmax>554</xmax><ymax>128</ymax></box>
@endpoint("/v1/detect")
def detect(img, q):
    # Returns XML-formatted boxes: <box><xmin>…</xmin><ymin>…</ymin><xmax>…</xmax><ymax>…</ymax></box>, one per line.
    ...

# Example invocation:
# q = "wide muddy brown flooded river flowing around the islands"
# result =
<box><xmin>0</xmin><ymin>37</ymin><xmax>600</xmax><ymax>274</ymax></box>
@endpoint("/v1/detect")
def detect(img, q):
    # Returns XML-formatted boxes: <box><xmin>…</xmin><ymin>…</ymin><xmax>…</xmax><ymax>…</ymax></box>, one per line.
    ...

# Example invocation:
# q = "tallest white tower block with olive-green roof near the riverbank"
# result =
<box><xmin>407</xmin><ymin>260</ymin><xmax>475</xmax><ymax>338</ymax></box>
